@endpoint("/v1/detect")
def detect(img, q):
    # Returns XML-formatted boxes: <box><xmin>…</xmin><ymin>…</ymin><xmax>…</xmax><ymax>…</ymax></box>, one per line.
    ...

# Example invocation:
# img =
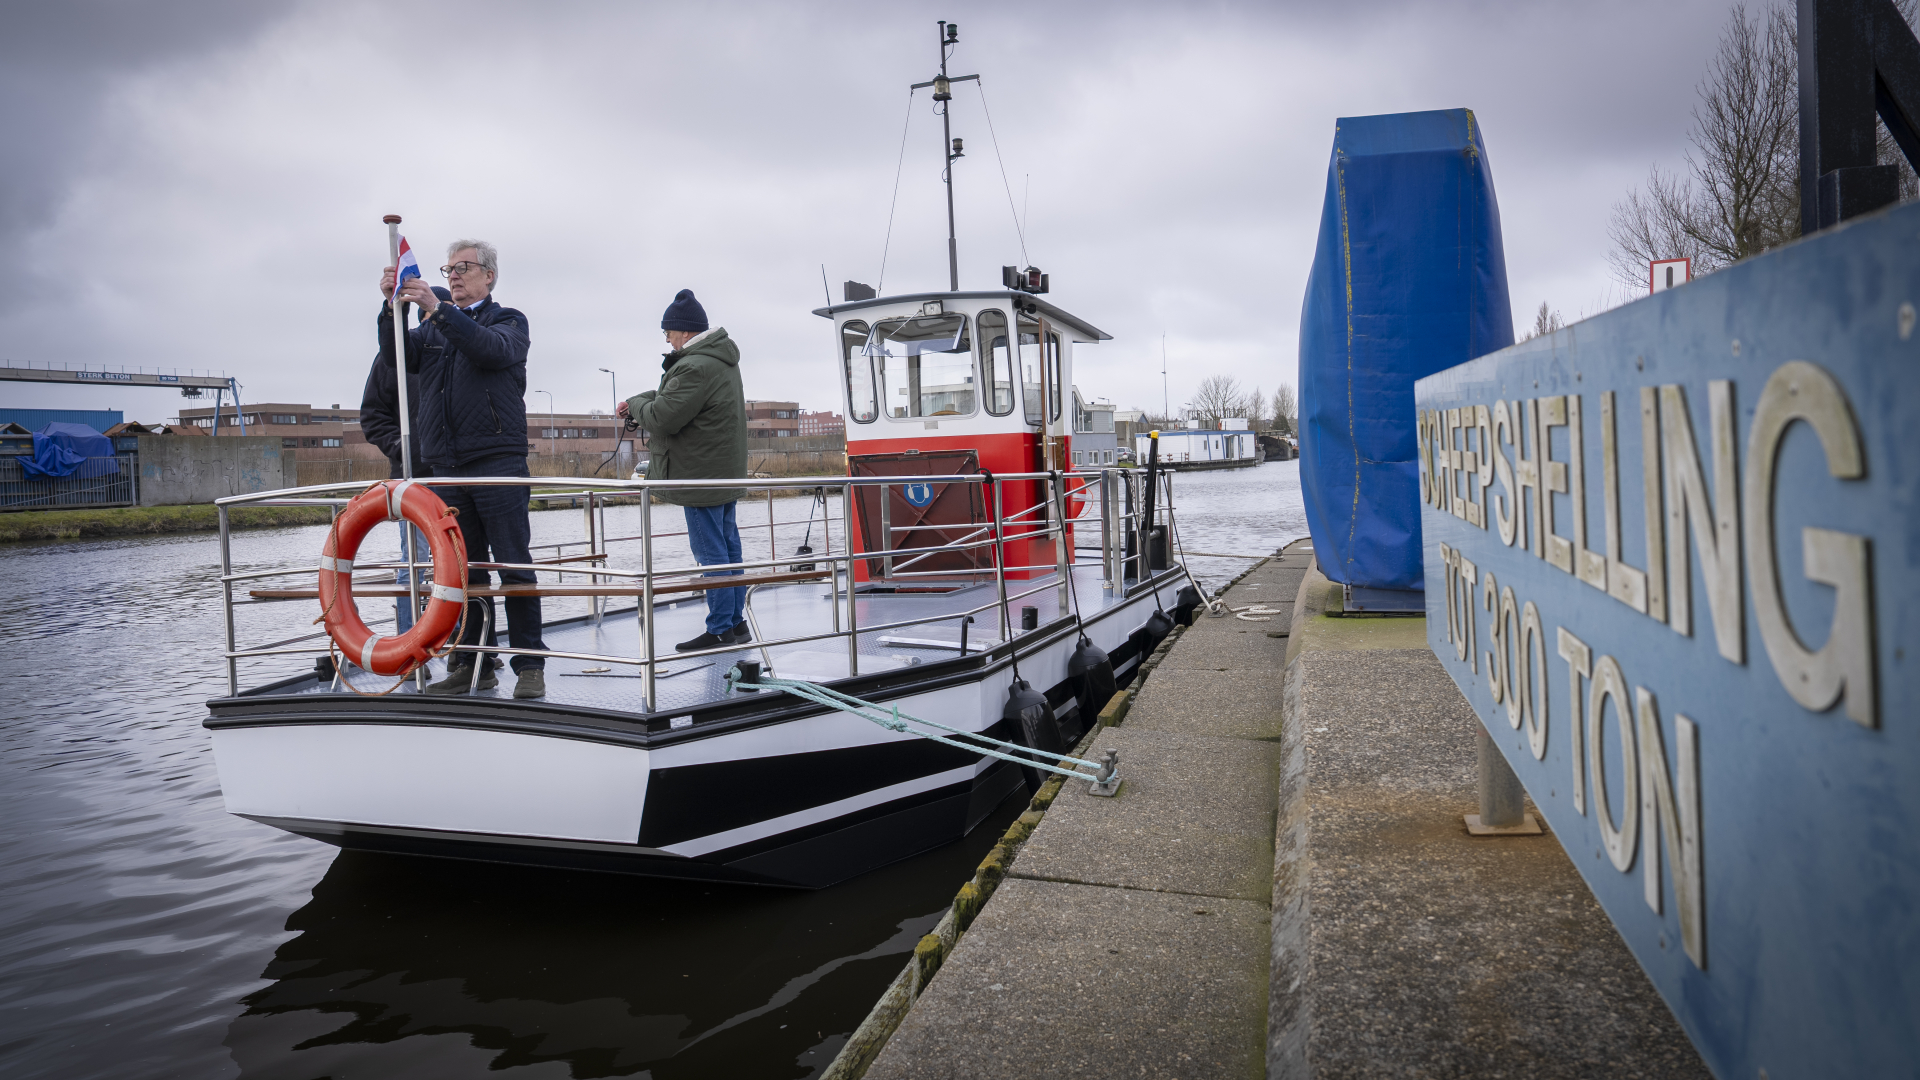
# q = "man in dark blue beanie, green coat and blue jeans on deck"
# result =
<box><xmin>614</xmin><ymin>288</ymin><xmax>753</xmax><ymax>651</ymax></box>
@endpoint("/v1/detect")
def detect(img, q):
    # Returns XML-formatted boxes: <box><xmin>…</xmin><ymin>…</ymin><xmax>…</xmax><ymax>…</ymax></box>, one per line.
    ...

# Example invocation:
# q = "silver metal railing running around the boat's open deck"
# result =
<box><xmin>215</xmin><ymin>467</ymin><xmax>1171</xmax><ymax>713</ymax></box>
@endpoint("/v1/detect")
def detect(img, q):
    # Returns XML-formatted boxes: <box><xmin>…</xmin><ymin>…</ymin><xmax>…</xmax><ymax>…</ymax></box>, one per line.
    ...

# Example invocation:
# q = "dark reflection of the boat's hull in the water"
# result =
<box><xmin>227</xmin><ymin>799</ymin><xmax>1021</xmax><ymax>1080</ymax></box>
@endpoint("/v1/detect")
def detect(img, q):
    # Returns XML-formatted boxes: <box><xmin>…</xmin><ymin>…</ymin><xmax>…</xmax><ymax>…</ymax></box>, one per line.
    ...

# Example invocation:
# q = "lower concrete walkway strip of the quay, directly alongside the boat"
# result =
<box><xmin>860</xmin><ymin>550</ymin><xmax>1308</xmax><ymax>1080</ymax></box>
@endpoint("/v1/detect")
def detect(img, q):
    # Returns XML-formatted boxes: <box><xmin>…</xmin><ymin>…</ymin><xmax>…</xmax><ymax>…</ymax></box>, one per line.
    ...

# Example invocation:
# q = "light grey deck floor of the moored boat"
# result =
<box><xmin>274</xmin><ymin>565</ymin><xmax>1179</xmax><ymax>715</ymax></box>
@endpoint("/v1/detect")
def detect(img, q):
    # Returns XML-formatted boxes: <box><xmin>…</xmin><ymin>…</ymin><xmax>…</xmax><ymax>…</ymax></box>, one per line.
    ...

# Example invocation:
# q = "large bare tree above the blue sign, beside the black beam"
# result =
<box><xmin>1607</xmin><ymin>0</ymin><xmax>1920</xmax><ymax>290</ymax></box>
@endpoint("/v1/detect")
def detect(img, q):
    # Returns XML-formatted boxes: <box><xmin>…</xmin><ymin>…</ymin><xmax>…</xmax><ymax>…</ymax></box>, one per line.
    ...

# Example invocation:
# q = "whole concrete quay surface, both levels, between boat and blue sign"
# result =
<box><xmin>866</xmin><ymin>542</ymin><xmax>1709</xmax><ymax>1080</ymax></box>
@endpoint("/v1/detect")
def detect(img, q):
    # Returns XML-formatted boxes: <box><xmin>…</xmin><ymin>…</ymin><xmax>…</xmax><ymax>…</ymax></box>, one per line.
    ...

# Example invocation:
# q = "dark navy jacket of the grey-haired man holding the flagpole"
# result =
<box><xmin>380</xmin><ymin>298</ymin><xmax>528</xmax><ymax>469</ymax></box>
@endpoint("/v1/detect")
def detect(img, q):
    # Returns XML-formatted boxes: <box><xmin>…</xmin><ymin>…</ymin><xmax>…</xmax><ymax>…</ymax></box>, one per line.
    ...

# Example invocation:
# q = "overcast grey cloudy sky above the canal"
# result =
<box><xmin>0</xmin><ymin>0</ymin><xmax>1728</xmax><ymax>423</ymax></box>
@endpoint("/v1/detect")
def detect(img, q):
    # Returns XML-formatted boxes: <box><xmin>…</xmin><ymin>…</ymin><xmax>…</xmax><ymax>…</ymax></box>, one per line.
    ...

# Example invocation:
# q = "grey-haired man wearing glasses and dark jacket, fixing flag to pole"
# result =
<box><xmin>378</xmin><ymin>240</ymin><xmax>547</xmax><ymax>698</ymax></box>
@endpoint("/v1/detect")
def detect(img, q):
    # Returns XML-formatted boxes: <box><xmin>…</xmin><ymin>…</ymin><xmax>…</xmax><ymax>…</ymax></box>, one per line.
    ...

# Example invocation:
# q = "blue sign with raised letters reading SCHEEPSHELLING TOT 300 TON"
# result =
<box><xmin>1415</xmin><ymin>206</ymin><xmax>1920</xmax><ymax>1078</ymax></box>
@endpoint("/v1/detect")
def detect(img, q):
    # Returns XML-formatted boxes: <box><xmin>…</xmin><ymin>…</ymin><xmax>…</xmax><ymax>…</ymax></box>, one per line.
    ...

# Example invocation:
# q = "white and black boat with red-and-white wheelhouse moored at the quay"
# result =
<box><xmin>204</xmin><ymin>25</ymin><xmax>1198</xmax><ymax>888</ymax></box>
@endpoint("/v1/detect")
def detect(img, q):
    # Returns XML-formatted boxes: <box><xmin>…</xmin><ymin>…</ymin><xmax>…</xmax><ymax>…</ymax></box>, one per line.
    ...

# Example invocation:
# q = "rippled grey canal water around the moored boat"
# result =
<box><xmin>0</xmin><ymin>461</ymin><xmax>1306</xmax><ymax>1080</ymax></box>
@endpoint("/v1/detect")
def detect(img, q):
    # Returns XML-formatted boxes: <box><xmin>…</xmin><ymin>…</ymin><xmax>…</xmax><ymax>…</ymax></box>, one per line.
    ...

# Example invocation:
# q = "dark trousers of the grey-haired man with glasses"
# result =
<box><xmin>434</xmin><ymin>454</ymin><xmax>547</xmax><ymax>673</ymax></box>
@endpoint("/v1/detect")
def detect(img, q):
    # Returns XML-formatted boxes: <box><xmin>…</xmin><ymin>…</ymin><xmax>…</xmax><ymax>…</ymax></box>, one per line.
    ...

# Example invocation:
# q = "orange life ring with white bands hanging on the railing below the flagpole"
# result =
<box><xmin>321</xmin><ymin>480</ymin><xmax>467</xmax><ymax>676</ymax></box>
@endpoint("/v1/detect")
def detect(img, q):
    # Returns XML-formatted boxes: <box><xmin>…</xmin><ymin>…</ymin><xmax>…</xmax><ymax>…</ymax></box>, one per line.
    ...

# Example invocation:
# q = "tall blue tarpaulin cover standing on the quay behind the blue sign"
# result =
<box><xmin>1300</xmin><ymin>110</ymin><xmax>1513</xmax><ymax>590</ymax></box>
